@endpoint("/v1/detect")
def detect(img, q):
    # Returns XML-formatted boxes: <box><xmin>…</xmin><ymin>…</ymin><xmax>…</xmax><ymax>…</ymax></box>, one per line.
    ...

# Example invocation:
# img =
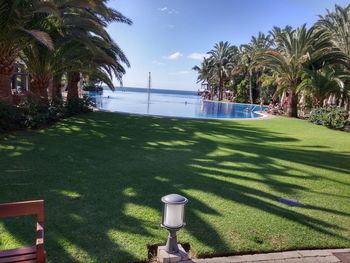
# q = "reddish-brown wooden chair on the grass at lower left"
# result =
<box><xmin>0</xmin><ymin>200</ymin><xmax>46</xmax><ymax>263</ymax></box>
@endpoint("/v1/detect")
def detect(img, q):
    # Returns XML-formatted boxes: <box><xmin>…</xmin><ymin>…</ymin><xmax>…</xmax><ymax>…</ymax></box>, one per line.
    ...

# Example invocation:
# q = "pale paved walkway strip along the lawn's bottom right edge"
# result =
<box><xmin>187</xmin><ymin>248</ymin><xmax>350</xmax><ymax>263</ymax></box>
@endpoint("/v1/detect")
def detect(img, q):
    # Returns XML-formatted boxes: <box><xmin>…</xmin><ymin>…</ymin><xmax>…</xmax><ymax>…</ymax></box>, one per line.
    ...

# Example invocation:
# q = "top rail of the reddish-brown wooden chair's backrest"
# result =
<box><xmin>0</xmin><ymin>200</ymin><xmax>44</xmax><ymax>222</ymax></box>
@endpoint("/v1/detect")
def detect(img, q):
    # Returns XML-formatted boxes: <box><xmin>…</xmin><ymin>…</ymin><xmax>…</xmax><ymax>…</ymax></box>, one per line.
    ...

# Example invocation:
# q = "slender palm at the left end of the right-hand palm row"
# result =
<box><xmin>208</xmin><ymin>41</ymin><xmax>238</xmax><ymax>100</ymax></box>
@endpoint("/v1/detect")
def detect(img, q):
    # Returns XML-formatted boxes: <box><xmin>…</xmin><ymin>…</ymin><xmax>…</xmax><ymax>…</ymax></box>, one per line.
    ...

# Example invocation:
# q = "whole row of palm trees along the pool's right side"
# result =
<box><xmin>193</xmin><ymin>5</ymin><xmax>350</xmax><ymax>117</ymax></box>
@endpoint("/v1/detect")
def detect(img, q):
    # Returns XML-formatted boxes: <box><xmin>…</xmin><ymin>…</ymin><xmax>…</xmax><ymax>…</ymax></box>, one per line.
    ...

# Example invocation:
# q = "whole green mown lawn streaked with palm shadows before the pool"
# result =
<box><xmin>0</xmin><ymin>113</ymin><xmax>350</xmax><ymax>262</ymax></box>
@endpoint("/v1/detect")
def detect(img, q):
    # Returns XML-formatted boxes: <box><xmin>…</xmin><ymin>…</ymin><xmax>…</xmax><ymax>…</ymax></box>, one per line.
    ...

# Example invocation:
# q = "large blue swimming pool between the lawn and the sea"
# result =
<box><xmin>90</xmin><ymin>89</ymin><xmax>262</xmax><ymax>119</ymax></box>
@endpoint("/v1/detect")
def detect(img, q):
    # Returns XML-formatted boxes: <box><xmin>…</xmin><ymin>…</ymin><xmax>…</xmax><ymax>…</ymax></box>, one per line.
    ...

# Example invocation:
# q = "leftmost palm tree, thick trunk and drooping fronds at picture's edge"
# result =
<box><xmin>0</xmin><ymin>0</ymin><xmax>57</xmax><ymax>102</ymax></box>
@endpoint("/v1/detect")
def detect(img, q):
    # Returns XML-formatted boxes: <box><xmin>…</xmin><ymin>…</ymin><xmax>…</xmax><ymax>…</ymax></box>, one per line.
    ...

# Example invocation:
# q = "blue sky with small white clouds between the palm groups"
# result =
<box><xmin>107</xmin><ymin>0</ymin><xmax>349</xmax><ymax>91</ymax></box>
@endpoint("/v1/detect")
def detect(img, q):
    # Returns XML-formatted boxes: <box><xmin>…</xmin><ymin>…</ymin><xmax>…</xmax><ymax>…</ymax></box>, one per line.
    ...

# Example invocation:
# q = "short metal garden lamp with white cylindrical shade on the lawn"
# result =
<box><xmin>161</xmin><ymin>194</ymin><xmax>188</xmax><ymax>254</ymax></box>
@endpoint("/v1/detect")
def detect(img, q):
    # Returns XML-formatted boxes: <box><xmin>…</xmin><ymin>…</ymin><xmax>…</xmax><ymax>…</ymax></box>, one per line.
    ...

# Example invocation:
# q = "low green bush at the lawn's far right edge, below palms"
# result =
<box><xmin>309</xmin><ymin>106</ymin><xmax>347</xmax><ymax>129</ymax></box>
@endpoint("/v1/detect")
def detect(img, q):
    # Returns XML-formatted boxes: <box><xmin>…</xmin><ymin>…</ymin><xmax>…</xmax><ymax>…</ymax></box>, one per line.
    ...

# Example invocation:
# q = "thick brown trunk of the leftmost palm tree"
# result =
<box><xmin>0</xmin><ymin>44</ymin><xmax>16</xmax><ymax>103</ymax></box>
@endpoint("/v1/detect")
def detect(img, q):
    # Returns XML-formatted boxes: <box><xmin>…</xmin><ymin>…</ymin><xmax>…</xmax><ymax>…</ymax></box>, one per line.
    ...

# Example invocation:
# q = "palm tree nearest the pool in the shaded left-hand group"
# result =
<box><xmin>61</xmin><ymin>0</ymin><xmax>132</xmax><ymax>98</ymax></box>
